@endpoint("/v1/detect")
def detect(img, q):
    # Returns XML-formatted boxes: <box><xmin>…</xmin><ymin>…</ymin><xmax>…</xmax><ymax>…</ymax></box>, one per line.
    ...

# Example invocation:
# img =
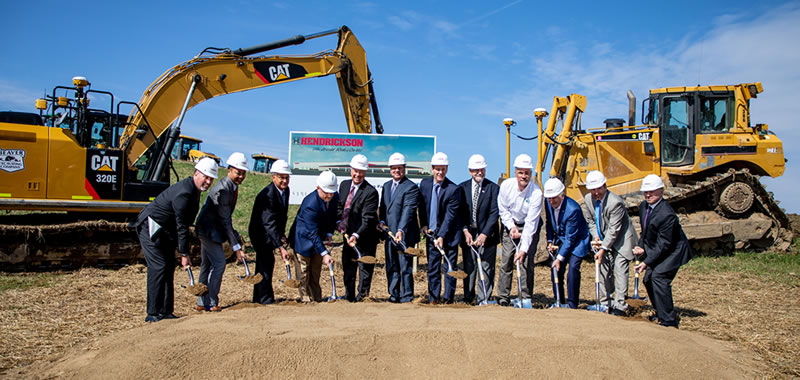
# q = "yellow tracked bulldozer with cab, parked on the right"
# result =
<box><xmin>534</xmin><ymin>82</ymin><xmax>792</xmax><ymax>254</ymax></box>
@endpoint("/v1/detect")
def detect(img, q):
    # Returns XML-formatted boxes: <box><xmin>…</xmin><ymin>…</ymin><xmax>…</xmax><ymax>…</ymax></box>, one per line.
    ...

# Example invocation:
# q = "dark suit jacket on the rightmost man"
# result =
<box><xmin>639</xmin><ymin>199</ymin><xmax>692</xmax><ymax>273</ymax></box>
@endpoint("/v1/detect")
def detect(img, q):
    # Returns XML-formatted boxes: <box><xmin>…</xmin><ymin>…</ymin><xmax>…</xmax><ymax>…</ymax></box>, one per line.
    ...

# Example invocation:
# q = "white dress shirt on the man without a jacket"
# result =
<box><xmin>497</xmin><ymin>178</ymin><xmax>544</xmax><ymax>252</ymax></box>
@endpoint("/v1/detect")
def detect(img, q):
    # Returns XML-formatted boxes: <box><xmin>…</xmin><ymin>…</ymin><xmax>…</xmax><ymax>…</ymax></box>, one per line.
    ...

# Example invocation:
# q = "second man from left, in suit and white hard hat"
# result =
<box><xmin>196</xmin><ymin>152</ymin><xmax>247</xmax><ymax>311</ymax></box>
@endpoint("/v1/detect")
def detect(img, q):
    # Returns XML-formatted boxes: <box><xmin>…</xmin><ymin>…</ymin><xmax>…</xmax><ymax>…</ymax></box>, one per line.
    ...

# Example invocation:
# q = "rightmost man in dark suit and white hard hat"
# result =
<box><xmin>633</xmin><ymin>174</ymin><xmax>692</xmax><ymax>328</ymax></box>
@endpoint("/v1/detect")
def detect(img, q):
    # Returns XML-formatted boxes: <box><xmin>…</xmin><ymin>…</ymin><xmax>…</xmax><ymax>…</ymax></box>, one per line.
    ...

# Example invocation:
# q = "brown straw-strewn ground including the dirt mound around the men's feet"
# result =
<box><xmin>0</xmin><ymin>243</ymin><xmax>800</xmax><ymax>379</ymax></box>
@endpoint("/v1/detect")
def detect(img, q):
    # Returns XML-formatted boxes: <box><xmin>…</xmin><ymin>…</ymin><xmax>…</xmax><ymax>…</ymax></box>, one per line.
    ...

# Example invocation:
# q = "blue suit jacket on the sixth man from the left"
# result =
<box><xmin>378</xmin><ymin>177</ymin><xmax>420</xmax><ymax>247</ymax></box>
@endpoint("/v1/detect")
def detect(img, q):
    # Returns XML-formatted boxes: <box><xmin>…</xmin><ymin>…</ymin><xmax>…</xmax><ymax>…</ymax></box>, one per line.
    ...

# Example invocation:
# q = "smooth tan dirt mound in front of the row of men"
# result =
<box><xmin>15</xmin><ymin>301</ymin><xmax>755</xmax><ymax>379</ymax></box>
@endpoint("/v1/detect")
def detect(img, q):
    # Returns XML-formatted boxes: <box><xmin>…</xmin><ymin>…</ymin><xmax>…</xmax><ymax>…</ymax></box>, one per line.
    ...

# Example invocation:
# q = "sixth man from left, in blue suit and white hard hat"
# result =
<box><xmin>379</xmin><ymin>153</ymin><xmax>420</xmax><ymax>302</ymax></box>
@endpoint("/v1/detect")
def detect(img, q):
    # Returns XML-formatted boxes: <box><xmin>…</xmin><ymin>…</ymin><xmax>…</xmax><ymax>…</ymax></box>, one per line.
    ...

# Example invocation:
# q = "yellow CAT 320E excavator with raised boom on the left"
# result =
<box><xmin>0</xmin><ymin>26</ymin><xmax>383</xmax><ymax>269</ymax></box>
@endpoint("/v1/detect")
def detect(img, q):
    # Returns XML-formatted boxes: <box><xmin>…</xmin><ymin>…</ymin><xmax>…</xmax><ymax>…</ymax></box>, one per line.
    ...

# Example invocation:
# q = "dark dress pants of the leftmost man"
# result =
<box><xmin>137</xmin><ymin>223</ymin><xmax>175</xmax><ymax>315</ymax></box>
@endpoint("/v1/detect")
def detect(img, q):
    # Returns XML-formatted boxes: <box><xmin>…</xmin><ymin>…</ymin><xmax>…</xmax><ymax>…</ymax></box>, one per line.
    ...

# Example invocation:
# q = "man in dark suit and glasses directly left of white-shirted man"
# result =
<box><xmin>459</xmin><ymin>154</ymin><xmax>500</xmax><ymax>303</ymax></box>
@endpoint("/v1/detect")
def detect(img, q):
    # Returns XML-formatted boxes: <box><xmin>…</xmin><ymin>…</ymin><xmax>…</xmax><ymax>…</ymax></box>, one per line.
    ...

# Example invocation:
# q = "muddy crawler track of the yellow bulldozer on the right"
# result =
<box><xmin>623</xmin><ymin>169</ymin><xmax>793</xmax><ymax>255</ymax></box>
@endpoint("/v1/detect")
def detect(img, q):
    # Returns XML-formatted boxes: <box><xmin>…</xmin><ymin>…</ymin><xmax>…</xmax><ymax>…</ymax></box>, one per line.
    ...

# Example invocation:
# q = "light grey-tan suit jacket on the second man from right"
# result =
<box><xmin>583</xmin><ymin>191</ymin><xmax>637</xmax><ymax>260</ymax></box>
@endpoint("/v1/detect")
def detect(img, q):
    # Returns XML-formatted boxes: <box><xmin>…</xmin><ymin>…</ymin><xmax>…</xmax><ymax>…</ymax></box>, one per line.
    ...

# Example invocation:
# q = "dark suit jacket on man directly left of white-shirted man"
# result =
<box><xmin>458</xmin><ymin>178</ymin><xmax>500</xmax><ymax>245</ymax></box>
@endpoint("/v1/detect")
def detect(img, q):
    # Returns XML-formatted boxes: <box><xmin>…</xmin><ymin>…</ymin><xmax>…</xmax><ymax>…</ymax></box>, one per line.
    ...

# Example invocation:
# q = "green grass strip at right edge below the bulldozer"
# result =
<box><xmin>685</xmin><ymin>241</ymin><xmax>800</xmax><ymax>286</ymax></box>
